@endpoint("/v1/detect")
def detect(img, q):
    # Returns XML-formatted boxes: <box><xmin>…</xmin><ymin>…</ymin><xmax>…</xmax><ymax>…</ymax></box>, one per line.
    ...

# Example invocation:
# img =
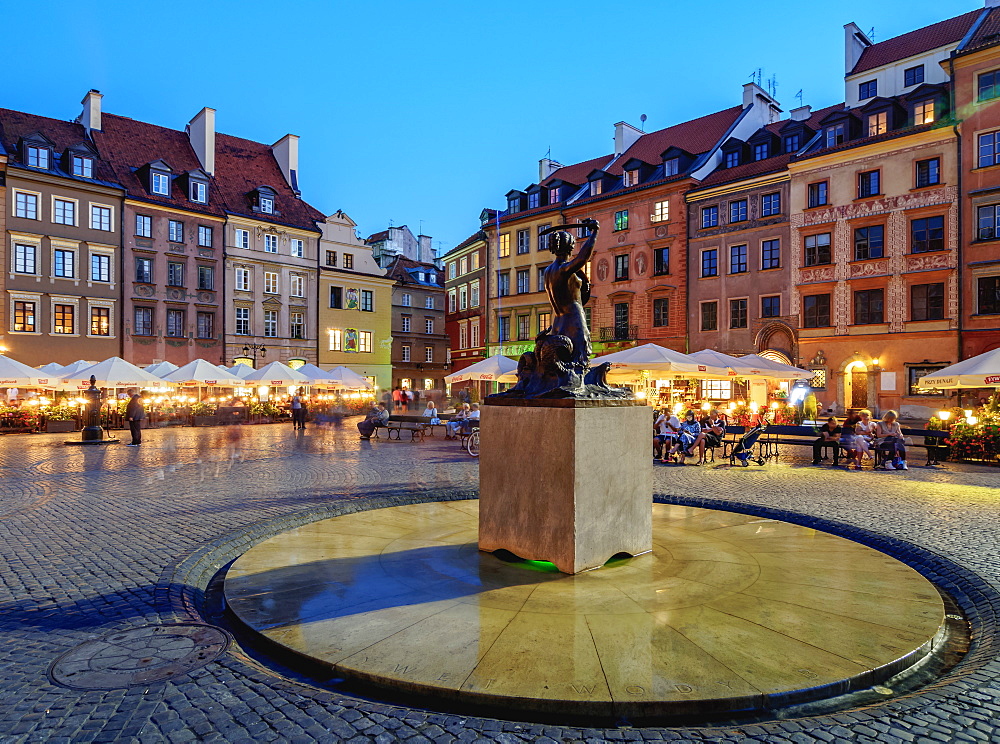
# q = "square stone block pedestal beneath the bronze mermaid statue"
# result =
<box><xmin>479</xmin><ymin>400</ymin><xmax>653</xmax><ymax>574</ymax></box>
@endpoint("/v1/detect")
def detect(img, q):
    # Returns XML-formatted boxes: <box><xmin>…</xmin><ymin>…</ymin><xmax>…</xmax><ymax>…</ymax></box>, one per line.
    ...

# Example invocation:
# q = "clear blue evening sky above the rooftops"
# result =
<box><xmin>0</xmin><ymin>0</ymin><xmax>982</xmax><ymax>251</ymax></box>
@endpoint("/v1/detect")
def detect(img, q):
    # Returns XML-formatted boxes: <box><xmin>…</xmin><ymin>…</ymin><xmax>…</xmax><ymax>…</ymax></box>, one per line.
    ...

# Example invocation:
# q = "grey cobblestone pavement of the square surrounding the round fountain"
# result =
<box><xmin>0</xmin><ymin>421</ymin><xmax>1000</xmax><ymax>744</ymax></box>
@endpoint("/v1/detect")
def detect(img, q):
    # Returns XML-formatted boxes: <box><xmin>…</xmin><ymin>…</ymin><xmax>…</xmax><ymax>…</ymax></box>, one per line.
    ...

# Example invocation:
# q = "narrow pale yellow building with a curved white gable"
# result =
<box><xmin>319</xmin><ymin>211</ymin><xmax>393</xmax><ymax>391</ymax></box>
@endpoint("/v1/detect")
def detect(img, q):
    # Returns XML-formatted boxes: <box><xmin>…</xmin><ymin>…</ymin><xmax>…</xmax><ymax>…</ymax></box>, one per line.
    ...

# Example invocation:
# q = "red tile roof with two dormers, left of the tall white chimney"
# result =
<box><xmin>94</xmin><ymin>113</ymin><xmax>226</xmax><ymax>216</ymax></box>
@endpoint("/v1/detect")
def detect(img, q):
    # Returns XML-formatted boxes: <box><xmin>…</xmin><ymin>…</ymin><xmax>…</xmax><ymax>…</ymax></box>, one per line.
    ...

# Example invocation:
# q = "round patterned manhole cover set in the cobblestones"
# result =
<box><xmin>49</xmin><ymin>623</ymin><xmax>229</xmax><ymax>690</ymax></box>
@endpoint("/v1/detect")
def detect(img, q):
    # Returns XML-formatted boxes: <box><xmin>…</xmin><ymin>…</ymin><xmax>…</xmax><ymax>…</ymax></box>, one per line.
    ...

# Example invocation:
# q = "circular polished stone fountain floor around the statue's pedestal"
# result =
<box><xmin>225</xmin><ymin>501</ymin><xmax>945</xmax><ymax>715</ymax></box>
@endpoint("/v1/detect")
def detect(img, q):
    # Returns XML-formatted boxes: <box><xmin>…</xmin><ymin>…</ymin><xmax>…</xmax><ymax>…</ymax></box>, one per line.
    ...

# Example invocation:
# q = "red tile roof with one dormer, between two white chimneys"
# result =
<box><xmin>215</xmin><ymin>133</ymin><xmax>325</xmax><ymax>232</ymax></box>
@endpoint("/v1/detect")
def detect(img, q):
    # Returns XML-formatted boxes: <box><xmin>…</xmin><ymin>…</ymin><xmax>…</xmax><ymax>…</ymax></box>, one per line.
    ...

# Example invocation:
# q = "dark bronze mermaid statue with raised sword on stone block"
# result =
<box><xmin>490</xmin><ymin>220</ymin><xmax>631</xmax><ymax>399</ymax></box>
